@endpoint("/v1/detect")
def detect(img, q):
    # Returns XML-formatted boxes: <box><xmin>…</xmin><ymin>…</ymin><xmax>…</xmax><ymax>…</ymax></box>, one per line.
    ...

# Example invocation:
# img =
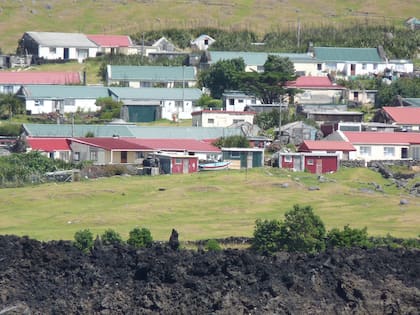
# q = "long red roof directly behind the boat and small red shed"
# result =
<box><xmin>126</xmin><ymin>138</ymin><xmax>221</xmax><ymax>152</ymax></box>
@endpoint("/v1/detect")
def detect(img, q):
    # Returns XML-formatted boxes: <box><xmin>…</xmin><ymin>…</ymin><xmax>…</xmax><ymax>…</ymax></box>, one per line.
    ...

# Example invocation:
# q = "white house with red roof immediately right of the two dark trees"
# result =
<box><xmin>286</xmin><ymin>76</ymin><xmax>347</xmax><ymax>104</ymax></box>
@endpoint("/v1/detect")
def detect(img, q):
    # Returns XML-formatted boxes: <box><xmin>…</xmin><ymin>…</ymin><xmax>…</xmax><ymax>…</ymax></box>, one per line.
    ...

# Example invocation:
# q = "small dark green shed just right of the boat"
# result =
<box><xmin>222</xmin><ymin>148</ymin><xmax>264</xmax><ymax>169</ymax></box>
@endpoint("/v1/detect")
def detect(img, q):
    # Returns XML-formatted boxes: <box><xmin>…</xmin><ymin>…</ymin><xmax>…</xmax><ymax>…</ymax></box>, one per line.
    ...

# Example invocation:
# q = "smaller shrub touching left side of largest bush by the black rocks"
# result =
<box><xmin>251</xmin><ymin>219</ymin><xmax>281</xmax><ymax>254</ymax></box>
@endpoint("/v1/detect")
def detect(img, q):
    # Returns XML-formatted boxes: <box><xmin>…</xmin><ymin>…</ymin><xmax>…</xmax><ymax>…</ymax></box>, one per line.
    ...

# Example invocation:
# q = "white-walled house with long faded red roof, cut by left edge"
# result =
<box><xmin>0</xmin><ymin>71</ymin><xmax>82</xmax><ymax>94</ymax></box>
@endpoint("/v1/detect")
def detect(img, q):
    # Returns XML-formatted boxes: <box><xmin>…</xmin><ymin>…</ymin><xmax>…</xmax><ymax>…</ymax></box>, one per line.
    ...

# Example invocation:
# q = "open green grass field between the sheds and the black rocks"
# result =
<box><xmin>0</xmin><ymin>168</ymin><xmax>420</xmax><ymax>241</ymax></box>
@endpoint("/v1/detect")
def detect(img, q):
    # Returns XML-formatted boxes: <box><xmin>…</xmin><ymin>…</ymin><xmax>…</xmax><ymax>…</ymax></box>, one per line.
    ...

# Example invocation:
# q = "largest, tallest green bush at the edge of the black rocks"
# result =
<box><xmin>280</xmin><ymin>205</ymin><xmax>326</xmax><ymax>253</ymax></box>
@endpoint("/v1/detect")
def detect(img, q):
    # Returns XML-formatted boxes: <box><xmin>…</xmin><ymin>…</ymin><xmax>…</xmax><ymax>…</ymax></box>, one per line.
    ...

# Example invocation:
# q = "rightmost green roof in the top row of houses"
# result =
<box><xmin>314</xmin><ymin>47</ymin><xmax>385</xmax><ymax>63</ymax></box>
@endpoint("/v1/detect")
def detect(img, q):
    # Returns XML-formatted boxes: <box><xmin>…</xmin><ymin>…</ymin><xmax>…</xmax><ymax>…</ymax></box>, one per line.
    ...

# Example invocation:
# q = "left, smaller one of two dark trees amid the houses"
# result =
<box><xmin>199</xmin><ymin>58</ymin><xmax>245</xmax><ymax>99</ymax></box>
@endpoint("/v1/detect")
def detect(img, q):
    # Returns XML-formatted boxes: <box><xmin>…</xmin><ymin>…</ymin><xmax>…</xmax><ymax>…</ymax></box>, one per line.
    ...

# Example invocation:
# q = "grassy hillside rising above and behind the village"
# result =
<box><xmin>0</xmin><ymin>0</ymin><xmax>420</xmax><ymax>53</ymax></box>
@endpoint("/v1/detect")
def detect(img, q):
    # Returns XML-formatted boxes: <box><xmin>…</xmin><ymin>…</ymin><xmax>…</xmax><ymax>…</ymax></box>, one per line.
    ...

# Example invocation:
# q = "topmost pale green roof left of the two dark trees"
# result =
<box><xmin>108</xmin><ymin>65</ymin><xmax>196</xmax><ymax>82</ymax></box>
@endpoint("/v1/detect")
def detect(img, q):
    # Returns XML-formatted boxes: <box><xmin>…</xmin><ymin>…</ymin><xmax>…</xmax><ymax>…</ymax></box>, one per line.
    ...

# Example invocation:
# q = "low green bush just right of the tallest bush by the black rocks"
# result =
<box><xmin>327</xmin><ymin>225</ymin><xmax>372</xmax><ymax>248</ymax></box>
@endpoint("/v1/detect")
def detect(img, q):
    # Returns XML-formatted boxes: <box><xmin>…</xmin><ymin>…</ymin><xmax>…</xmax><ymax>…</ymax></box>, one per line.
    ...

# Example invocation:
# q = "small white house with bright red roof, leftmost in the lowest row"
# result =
<box><xmin>25</xmin><ymin>137</ymin><xmax>72</xmax><ymax>162</ymax></box>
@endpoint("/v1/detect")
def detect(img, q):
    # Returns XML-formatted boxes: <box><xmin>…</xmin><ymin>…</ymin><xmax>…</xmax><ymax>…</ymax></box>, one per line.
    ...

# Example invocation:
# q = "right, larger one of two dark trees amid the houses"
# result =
<box><xmin>239</xmin><ymin>55</ymin><xmax>296</xmax><ymax>104</ymax></box>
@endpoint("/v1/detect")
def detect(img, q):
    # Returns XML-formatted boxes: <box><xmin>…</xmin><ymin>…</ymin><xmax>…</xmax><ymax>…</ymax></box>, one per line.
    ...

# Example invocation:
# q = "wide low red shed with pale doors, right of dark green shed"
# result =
<box><xmin>277</xmin><ymin>152</ymin><xmax>339</xmax><ymax>174</ymax></box>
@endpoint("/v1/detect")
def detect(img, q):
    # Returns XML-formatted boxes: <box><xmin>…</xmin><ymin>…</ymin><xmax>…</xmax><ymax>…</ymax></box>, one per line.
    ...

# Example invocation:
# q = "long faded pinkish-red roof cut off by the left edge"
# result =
<box><xmin>0</xmin><ymin>71</ymin><xmax>81</xmax><ymax>84</ymax></box>
